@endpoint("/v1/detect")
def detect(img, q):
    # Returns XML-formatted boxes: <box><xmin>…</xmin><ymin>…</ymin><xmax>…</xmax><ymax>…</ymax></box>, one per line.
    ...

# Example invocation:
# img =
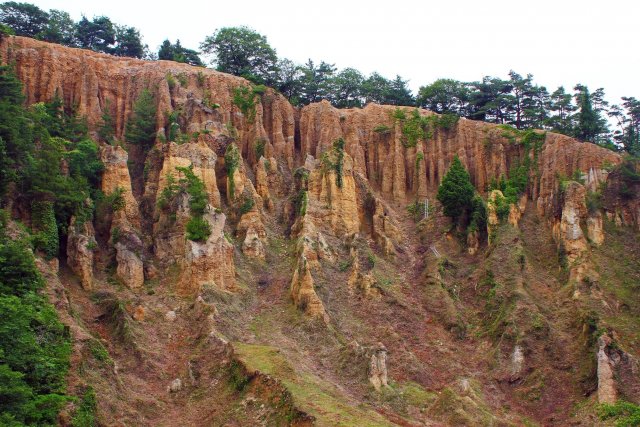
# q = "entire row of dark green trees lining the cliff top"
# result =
<box><xmin>0</xmin><ymin>2</ymin><xmax>640</xmax><ymax>155</ymax></box>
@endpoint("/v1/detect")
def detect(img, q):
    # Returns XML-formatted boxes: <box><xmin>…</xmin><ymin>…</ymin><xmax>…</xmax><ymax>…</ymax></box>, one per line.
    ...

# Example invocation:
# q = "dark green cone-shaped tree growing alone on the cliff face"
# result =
<box><xmin>437</xmin><ymin>156</ymin><xmax>475</xmax><ymax>221</ymax></box>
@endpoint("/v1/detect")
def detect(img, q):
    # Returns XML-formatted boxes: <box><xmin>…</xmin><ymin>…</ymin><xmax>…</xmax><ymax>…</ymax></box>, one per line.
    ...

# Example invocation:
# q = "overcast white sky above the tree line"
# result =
<box><xmin>31</xmin><ymin>0</ymin><xmax>640</xmax><ymax>103</ymax></box>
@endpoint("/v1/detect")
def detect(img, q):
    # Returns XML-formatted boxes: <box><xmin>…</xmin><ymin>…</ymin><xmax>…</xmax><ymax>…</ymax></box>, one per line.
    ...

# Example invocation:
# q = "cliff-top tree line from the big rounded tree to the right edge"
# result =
<box><xmin>200</xmin><ymin>27</ymin><xmax>640</xmax><ymax>155</ymax></box>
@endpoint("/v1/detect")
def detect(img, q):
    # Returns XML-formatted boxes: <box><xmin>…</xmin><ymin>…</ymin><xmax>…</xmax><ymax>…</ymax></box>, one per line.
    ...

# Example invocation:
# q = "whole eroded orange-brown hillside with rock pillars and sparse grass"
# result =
<box><xmin>0</xmin><ymin>37</ymin><xmax>640</xmax><ymax>426</ymax></box>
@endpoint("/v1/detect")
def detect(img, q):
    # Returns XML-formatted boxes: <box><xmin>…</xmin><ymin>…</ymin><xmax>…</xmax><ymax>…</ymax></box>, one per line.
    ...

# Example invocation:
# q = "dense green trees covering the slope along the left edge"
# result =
<box><xmin>0</xmin><ymin>62</ymin><xmax>103</xmax><ymax>426</ymax></box>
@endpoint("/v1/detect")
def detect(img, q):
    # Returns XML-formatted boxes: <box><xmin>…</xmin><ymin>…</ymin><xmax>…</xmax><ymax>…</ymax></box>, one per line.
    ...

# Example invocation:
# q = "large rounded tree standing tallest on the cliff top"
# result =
<box><xmin>200</xmin><ymin>27</ymin><xmax>278</xmax><ymax>85</ymax></box>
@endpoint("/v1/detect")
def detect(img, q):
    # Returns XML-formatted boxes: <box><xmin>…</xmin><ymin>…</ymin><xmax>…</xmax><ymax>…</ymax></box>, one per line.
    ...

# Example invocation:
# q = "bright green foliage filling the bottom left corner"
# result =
<box><xmin>0</xmin><ymin>221</ymin><xmax>71</xmax><ymax>425</ymax></box>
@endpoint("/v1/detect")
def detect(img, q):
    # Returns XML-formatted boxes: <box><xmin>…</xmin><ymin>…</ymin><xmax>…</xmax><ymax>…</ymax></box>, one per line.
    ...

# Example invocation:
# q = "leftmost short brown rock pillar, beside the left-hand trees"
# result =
<box><xmin>67</xmin><ymin>217</ymin><xmax>98</xmax><ymax>290</ymax></box>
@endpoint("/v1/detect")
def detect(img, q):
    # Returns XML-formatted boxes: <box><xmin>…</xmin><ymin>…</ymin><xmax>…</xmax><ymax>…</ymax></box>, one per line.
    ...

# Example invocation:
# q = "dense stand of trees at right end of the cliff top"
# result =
<box><xmin>416</xmin><ymin>75</ymin><xmax>640</xmax><ymax>154</ymax></box>
